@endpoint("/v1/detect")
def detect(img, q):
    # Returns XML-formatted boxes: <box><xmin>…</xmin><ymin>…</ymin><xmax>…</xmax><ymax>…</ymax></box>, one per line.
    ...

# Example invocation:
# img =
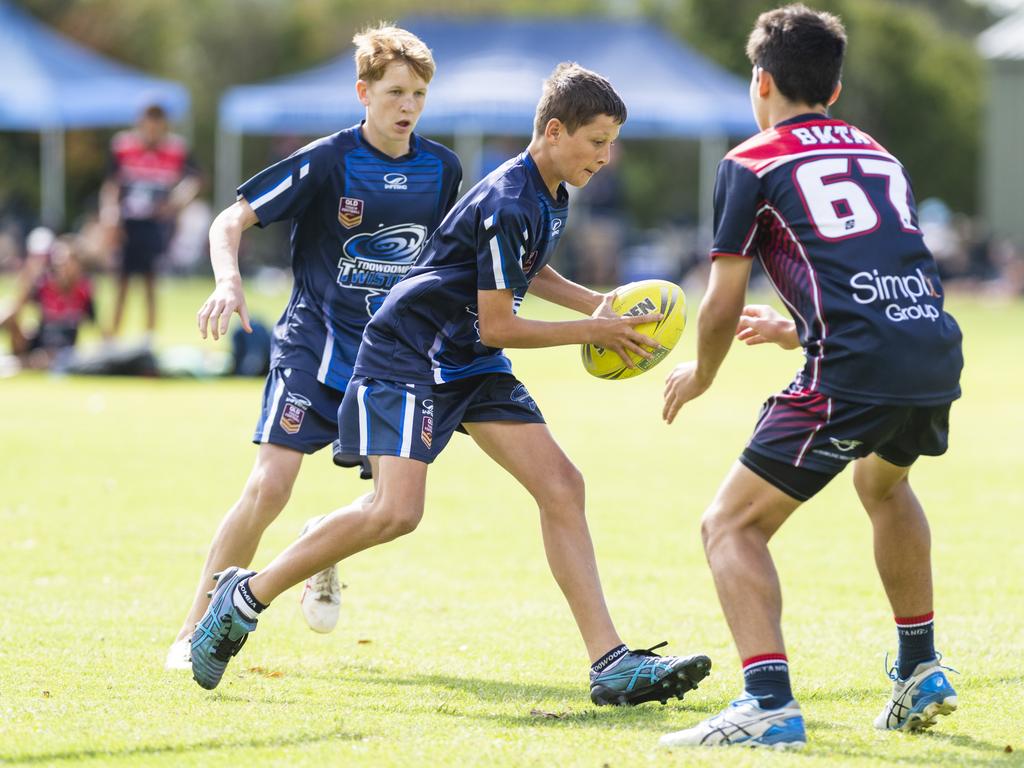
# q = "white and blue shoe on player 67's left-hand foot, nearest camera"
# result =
<box><xmin>658</xmin><ymin>696</ymin><xmax>807</xmax><ymax>750</ymax></box>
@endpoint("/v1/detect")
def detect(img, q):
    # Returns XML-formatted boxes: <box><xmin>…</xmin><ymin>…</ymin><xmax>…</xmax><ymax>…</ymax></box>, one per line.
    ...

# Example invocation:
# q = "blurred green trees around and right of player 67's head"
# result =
<box><xmin>645</xmin><ymin>0</ymin><xmax>991</xmax><ymax>213</ymax></box>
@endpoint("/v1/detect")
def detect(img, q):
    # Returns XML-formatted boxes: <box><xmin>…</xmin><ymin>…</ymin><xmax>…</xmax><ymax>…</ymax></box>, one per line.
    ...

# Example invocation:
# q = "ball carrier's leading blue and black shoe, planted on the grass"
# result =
<box><xmin>590</xmin><ymin>643</ymin><xmax>711</xmax><ymax>707</ymax></box>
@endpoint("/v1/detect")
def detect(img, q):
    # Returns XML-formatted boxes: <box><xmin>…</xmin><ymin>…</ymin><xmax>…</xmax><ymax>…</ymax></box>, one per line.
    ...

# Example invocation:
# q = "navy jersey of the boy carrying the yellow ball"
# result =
<box><xmin>355</xmin><ymin>152</ymin><xmax>568</xmax><ymax>384</ymax></box>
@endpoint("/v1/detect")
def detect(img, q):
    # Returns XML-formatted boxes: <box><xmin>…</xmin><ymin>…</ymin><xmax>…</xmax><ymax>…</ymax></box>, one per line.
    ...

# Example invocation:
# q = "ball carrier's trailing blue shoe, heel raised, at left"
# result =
<box><xmin>191</xmin><ymin>565</ymin><xmax>256</xmax><ymax>690</ymax></box>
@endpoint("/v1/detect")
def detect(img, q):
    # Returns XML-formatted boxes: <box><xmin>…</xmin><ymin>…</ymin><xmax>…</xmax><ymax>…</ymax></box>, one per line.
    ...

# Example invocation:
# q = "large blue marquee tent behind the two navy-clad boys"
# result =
<box><xmin>217</xmin><ymin>17</ymin><xmax>757</xmax><ymax>228</ymax></box>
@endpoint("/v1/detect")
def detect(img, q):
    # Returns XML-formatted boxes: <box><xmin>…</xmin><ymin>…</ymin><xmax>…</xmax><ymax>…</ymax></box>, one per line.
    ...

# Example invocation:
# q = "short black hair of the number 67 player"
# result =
<box><xmin>746</xmin><ymin>3</ymin><xmax>846</xmax><ymax>104</ymax></box>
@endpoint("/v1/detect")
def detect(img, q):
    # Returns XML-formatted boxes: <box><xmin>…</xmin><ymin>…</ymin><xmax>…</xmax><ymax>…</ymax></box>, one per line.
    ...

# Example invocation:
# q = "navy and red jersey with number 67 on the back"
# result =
<box><xmin>712</xmin><ymin>115</ymin><xmax>964</xmax><ymax>406</ymax></box>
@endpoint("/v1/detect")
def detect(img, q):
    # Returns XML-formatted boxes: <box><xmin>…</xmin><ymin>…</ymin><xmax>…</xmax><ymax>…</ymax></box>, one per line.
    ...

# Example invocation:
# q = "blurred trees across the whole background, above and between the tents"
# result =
<box><xmin>0</xmin><ymin>0</ymin><xmax>991</xmax><ymax>233</ymax></box>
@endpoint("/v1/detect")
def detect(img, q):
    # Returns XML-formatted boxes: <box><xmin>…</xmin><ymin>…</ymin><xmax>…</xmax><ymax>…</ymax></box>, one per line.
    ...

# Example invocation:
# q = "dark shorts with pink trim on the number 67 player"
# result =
<box><xmin>739</xmin><ymin>384</ymin><xmax>950</xmax><ymax>501</ymax></box>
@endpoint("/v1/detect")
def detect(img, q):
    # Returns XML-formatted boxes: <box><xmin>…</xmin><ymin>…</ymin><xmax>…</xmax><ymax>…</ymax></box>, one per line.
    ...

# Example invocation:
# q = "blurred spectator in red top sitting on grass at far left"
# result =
<box><xmin>0</xmin><ymin>233</ymin><xmax>96</xmax><ymax>369</ymax></box>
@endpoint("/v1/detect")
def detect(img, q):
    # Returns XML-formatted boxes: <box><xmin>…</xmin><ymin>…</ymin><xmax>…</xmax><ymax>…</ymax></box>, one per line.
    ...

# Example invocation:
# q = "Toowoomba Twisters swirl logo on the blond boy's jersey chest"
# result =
<box><xmin>338</xmin><ymin>224</ymin><xmax>427</xmax><ymax>301</ymax></box>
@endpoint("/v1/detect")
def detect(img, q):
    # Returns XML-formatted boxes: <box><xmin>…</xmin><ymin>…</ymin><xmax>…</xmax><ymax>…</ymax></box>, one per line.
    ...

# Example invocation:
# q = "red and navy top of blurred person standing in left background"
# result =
<box><xmin>109</xmin><ymin>131</ymin><xmax>198</xmax><ymax>219</ymax></box>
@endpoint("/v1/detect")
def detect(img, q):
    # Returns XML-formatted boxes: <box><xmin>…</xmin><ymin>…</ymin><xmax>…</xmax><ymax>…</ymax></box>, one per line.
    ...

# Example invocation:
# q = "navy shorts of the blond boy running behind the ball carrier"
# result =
<box><xmin>253</xmin><ymin>368</ymin><xmax>342</xmax><ymax>461</ymax></box>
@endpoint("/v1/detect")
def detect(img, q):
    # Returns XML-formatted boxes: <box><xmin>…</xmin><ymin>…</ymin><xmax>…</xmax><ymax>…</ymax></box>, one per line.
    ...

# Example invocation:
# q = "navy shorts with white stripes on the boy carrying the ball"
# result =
<box><xmin>338</xmin><ymin>374</ymin><xmax>544</xmax><ymax>464</ymax></box>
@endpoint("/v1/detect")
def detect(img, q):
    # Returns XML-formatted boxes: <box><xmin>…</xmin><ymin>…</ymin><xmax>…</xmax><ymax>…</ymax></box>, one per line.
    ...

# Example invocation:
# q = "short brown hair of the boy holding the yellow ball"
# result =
<box><xmin>534</xmin><ymin>61</ymin><xmax>626</xmax><ymax>136</ymax></box>
